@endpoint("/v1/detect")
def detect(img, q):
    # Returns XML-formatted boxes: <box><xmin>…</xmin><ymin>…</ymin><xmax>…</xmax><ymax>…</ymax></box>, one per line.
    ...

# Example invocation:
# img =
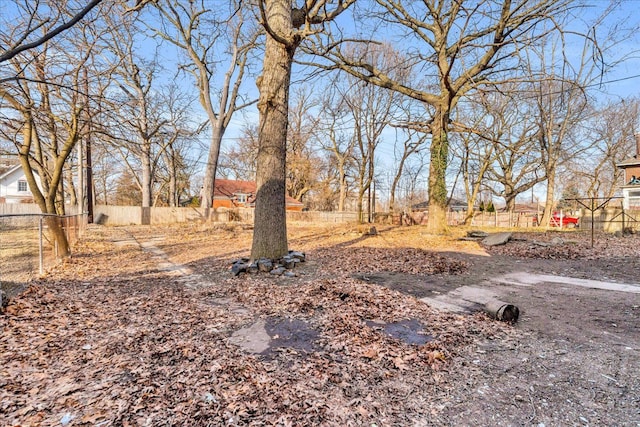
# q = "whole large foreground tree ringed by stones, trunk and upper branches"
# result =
<box><xmin>251</xmin><ymin>0</ymin><xmax>354</xmax><ymax>259</ymax></box>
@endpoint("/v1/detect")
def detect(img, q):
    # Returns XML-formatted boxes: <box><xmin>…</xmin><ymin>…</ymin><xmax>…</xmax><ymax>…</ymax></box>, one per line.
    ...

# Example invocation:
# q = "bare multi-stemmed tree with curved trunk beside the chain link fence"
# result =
<box><xmin>0</xmin><ymin>5</ymin><xmax>104</xmax><ymax>257</ymax></box>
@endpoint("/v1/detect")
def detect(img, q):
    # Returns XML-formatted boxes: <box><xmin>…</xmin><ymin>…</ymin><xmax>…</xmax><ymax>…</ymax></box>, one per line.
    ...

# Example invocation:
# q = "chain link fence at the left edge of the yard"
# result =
<box><xmin>0</xmin><ymin>214</ymin><xmax>86</xmax><ymax>295</ymax></box>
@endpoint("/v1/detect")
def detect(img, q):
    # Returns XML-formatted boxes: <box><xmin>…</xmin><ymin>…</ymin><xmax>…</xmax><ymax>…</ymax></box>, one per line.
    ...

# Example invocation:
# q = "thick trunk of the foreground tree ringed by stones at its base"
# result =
<box><xmin>251</xmin><ymin>0</ymin><xmax>295</xmax><ymax>260</ymax></box>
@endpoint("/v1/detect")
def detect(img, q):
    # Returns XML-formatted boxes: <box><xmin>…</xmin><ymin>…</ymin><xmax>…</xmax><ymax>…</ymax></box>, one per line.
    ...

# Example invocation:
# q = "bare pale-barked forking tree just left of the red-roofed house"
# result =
<box><xmin>154</xmin><ymin>0</ymin><xmax>258</xmax><ymax>214</ymax></box>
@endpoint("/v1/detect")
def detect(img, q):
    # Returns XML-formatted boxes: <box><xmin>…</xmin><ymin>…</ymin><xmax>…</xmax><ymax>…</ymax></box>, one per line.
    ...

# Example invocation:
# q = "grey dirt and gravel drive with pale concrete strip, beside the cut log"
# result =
<box><xmin>362</xmin><ymin>249</ymin><xmax>640</xmax><ymax>426</ymax></box>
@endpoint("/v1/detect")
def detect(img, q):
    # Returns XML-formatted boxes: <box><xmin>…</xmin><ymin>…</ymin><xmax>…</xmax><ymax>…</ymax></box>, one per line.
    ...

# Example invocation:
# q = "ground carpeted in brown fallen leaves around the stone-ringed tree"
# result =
<box><xmin>0</xmin><ymin>222</ymin><xmax>509</xmax><ymax>426</ymax></box>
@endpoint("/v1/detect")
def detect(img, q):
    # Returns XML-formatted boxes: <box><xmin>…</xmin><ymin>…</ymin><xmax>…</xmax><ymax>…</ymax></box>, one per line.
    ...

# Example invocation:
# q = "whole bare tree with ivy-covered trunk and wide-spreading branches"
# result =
<box><xmin>316</xmin><ymin>0</ymin><xmax>592</xmax><ymax>232</ymax></box>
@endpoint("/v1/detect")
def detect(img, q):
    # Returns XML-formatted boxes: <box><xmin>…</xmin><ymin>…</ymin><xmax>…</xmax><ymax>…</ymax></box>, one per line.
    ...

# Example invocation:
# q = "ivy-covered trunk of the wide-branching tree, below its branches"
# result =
<box><xmin>427</xmin><ymin>111</ymin><xmax>449</xmax><ymax>234</ymax></box>
